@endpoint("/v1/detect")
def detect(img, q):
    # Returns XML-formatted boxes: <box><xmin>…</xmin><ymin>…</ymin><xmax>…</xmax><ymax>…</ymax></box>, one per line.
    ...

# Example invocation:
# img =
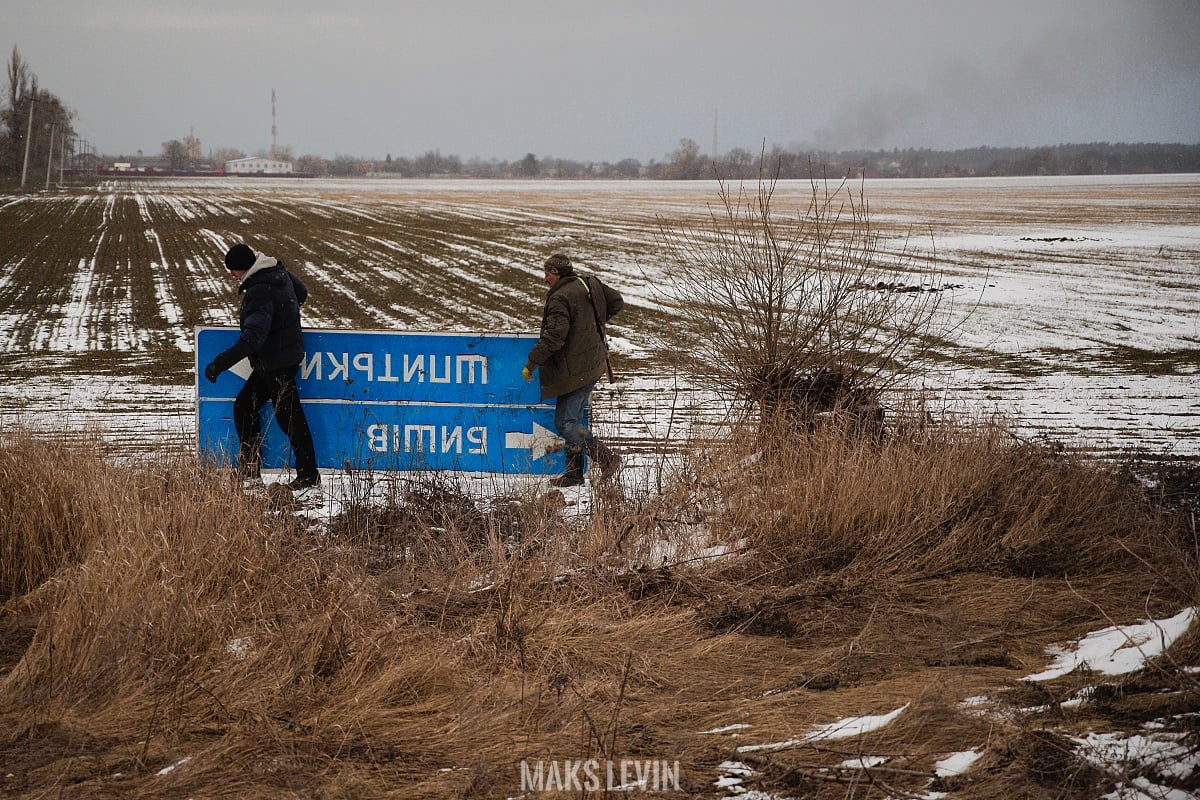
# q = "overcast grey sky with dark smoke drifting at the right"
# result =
<box><xmin>9</xmin><ymin>0</ymin><xmax>1200</xmax><ymax>163</ymax></box>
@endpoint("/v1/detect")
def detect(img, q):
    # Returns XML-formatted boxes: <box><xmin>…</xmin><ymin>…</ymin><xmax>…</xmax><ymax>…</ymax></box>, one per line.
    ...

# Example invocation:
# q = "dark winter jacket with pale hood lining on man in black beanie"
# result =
<box><xmin>212</xmin><ymin>255</ymin><xmax>308</xmax><ymax>371</ymax></box>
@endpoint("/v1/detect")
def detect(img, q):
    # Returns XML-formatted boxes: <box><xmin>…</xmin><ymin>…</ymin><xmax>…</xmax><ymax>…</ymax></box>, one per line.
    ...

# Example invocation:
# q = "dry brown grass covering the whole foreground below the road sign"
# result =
<box><xmin>0</xmin><ymin>426</ymin><xmax>1200</xmax><ymax>799</ymax></box>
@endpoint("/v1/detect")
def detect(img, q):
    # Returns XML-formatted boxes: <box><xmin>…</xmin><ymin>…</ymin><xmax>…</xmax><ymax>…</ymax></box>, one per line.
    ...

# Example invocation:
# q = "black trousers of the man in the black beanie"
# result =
<box><xmin>233</xmin><ymin>365</ymin><xmax>318</xmax><ymax>477</ymax></box>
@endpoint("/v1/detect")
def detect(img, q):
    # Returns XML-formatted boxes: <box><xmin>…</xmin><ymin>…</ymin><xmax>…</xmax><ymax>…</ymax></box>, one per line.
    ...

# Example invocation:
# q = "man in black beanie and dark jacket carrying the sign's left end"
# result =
<box><xmin>204</xmin><ymin>243</ymin><xmax>320</xmax><ymax>491</ymax></box>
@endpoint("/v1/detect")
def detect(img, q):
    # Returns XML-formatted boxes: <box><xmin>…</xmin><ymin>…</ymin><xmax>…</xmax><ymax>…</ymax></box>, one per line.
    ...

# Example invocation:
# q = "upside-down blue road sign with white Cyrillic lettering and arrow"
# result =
<box><xmin>196</xmin><ymin>327</ymin><xmax>565</xmax><ymax>475</ymax></box>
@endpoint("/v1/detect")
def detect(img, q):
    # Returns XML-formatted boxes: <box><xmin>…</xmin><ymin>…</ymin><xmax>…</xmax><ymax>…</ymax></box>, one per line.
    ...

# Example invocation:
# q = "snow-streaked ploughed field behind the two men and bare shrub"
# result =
<box><xmin>0</xmin><ymin>175</ymin><xmax>1200</xmax><ymax>457</ymax></box>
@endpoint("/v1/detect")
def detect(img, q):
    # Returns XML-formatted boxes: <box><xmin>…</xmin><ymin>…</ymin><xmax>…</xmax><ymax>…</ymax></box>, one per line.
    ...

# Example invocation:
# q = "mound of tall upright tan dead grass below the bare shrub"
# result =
<box><xmin>713</xmin><ymin>416</ymin><xmax>1187</xmax><ymax>585</ymax></box>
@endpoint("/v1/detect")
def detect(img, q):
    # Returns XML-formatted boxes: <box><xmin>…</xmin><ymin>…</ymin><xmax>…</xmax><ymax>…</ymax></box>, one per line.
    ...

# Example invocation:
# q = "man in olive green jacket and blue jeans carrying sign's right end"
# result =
<box><xmin>522</xmin><ymin>253</ymin><xmax>625</xmax><ymax>486</ymax></box>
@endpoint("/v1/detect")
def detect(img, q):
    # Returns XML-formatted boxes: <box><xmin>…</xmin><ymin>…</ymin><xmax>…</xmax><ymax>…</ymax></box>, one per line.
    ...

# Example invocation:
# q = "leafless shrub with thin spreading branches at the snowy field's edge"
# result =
<box><xmin>659</xmin><ymin>162</ymin><xmax>944</xmax><ymax>425</ymax></box>
